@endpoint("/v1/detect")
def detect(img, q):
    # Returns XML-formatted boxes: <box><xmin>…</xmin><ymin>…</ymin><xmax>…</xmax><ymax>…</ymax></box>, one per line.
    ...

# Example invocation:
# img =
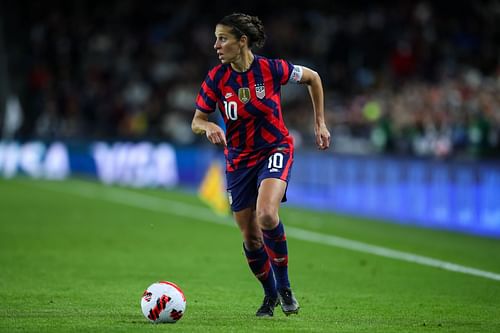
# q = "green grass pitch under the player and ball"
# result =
<box><xmin>0</xmin><ymin>179</ymin><xmax>500</xmax><ymax>333</ymax></box>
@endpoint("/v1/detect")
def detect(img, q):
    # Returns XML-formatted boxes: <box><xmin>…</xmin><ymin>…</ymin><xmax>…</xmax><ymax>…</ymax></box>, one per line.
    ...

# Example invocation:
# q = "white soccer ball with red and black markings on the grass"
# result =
<box><xmin>141</xmin><ymin>281</ymin><xmax>186</xmax><ymax>323</ymax></box>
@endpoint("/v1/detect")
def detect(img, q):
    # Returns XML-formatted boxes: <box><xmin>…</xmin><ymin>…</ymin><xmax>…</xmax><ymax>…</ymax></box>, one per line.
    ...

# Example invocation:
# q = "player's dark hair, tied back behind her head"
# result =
<box><xmin>219</xmin><ymin>13</ymin><xmax>266</xmax><ymax>49</ymax></box>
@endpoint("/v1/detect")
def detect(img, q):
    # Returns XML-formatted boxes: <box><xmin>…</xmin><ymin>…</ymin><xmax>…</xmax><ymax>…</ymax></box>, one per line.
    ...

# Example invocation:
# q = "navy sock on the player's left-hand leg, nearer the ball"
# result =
<box><xmin>243</xmin><ymin>244</ymin><xmax>278</xmax><ymax>298</ymax></box>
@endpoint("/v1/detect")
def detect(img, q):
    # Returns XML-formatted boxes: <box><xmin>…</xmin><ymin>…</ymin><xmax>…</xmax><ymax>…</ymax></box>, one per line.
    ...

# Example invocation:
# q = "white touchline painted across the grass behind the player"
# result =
<box><xmin>30</xmin><ymin>182</ymin><xmax>500</xmax><ymax>281</ymax></box>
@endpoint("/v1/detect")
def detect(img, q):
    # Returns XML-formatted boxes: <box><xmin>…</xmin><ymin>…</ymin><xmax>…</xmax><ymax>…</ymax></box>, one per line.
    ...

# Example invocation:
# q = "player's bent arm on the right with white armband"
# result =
<box><xmin>292</xmin><ymin>66</ymin><xmax>330</xmax><ymax>150</ymax></box>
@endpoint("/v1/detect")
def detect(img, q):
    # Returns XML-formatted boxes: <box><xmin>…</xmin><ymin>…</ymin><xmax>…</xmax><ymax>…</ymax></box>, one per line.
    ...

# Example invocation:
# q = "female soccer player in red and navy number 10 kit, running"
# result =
<box><xmin>191</xmin><ymin>13</ymin><xmax>330</xmax><ymax>317</ymax></box>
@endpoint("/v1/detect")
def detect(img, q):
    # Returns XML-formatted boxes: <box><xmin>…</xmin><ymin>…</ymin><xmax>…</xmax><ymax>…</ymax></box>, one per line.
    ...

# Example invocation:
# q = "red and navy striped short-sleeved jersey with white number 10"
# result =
<box><xmin>196</xmin><ymin>55</ymin><xmax>294</xmax><ymax>171</ymax></box>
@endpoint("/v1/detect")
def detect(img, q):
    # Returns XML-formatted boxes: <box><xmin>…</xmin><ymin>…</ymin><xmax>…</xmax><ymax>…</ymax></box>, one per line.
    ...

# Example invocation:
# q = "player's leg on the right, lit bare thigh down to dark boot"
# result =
<box><xmin>256</xmin><ymin>178</ymin><xmax>299</xmax><ymax>315</ymax></box>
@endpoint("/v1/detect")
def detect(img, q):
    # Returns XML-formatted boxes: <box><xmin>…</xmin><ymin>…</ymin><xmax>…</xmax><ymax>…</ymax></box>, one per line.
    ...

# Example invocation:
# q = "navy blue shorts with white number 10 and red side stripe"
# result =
<box><xmin>226</xmin><ymin>149</ymin><xmax>293</xmax><ymax>212</ymax></box>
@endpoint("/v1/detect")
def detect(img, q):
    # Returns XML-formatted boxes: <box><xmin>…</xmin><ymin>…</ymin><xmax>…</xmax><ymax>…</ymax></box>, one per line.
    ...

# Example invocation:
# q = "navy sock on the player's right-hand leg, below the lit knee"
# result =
<box><xmin>262</xmin><ymin>221</ymin><xmax>290</xmax><ymax>289</ymax></box>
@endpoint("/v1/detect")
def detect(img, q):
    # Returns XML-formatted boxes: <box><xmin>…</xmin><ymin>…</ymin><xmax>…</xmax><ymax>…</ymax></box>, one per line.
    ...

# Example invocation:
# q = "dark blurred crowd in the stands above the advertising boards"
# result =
<box><xmin>0</xmin><ymin>0</ymin><xmax>500</xmax><ymax>158</ymax></box>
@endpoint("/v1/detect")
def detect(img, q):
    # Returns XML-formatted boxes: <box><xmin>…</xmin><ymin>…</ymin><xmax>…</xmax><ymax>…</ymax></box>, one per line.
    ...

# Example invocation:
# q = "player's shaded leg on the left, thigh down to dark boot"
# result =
<box><xmin>233</xmin><ymin>207</ymin><xmax>278</xmax><ymax>317</ymax></box>
